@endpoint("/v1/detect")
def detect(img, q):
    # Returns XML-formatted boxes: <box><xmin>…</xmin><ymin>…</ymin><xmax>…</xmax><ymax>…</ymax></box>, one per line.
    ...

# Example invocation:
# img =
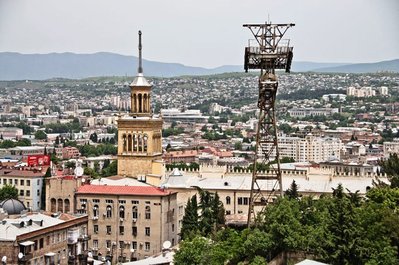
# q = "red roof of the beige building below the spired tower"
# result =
<box><xmin>76</xmin><ymin>184</ymin><xmax>170</xmax><ymax>196</ymax></box>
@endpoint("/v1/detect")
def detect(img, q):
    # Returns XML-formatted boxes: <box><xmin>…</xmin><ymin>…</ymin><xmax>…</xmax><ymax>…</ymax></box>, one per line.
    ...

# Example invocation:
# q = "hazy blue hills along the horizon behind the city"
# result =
<box><xmin>0</xmin><ymin>52</ymin><xmax>399</xmax><ymax>80</ymax></box>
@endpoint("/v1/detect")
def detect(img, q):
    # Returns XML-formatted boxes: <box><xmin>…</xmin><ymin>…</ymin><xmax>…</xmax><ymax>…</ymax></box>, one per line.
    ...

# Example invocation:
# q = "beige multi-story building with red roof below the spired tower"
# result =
<box><xmin>75</xmin><ymin>184</ymin><xmax>178</xmax><ymax>264</ymax></box>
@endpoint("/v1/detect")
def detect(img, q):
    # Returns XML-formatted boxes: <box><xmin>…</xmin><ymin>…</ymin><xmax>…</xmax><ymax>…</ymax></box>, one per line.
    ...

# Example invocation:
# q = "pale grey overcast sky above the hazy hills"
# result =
<box><xmin>0</xmin><ymin>0</ymin><xmax>399</xmax><ymax>68</ymax></box>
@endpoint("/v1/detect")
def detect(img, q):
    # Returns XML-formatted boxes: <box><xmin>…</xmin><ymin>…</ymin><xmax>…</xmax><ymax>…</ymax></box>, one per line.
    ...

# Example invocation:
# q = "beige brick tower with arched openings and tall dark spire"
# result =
<box><xmin>118</xmin><ymin>31</ymin><xmax>162</xmax><ymax>182</ymax></box>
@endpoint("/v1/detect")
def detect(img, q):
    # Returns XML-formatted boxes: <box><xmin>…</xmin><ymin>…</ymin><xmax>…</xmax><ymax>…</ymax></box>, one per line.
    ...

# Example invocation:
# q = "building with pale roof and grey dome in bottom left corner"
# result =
<box><xmin>0</xmin><ymin>199</ymin><xmax>88</xmax><ymax>265</ymax></box>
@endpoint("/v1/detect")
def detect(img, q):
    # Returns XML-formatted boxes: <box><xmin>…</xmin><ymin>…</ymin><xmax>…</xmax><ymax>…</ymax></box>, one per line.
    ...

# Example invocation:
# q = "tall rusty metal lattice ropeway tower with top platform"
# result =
<box><xmin>243</xmin><ymin>23</ymin><xmax>295</xmax><ymax>227</ymax></box>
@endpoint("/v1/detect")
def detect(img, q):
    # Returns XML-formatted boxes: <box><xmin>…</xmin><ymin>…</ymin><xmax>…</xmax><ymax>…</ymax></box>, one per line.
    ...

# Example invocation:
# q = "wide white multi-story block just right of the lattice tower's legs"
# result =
<box><xmin>264</xmin><ymin>134</ymin><xmax>343</xmax><ymax>162</ymax></box>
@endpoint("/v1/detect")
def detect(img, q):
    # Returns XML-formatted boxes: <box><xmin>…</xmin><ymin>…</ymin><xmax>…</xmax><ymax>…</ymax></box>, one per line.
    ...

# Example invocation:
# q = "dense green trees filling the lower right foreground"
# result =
<box><xmin>175</xmin><ymin>185</ymin><xmax>399</xmax><ymax>265</ymax></box>
